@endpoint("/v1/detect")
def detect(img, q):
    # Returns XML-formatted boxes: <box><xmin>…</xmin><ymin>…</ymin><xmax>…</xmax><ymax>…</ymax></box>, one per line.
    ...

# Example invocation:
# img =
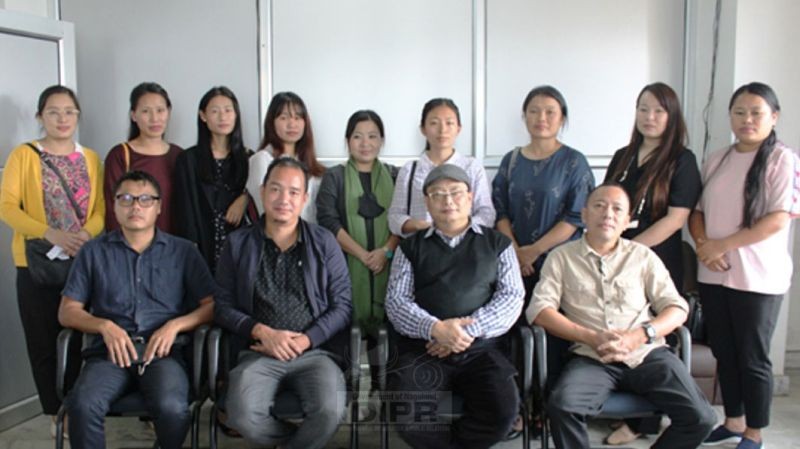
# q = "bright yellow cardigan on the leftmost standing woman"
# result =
<box><xmin>0</xmin><ymin>144</ymin><xmax>105</xmax><ymax>267</ymax></box>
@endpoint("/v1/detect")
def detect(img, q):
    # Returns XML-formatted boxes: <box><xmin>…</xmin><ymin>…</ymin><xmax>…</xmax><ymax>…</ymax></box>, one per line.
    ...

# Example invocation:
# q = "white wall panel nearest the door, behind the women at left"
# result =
<box><xmin>62</xmin><ymin>0</ymin><xmax>259</xmax><ymax>155</ymax></box>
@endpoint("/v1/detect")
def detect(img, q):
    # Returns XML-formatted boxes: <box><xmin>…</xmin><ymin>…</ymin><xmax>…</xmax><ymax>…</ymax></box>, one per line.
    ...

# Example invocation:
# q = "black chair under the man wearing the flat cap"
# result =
<box><xmin>378</xmin><ymin>326</ymin><xmax>535</xmax><ymax>449</ymax></box>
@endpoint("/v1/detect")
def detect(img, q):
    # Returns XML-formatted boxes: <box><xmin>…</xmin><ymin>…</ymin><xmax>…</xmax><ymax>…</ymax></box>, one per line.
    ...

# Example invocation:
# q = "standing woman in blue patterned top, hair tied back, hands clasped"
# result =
<box><xmin>492</xmin><ymin>86</ymin><xmax>594</xmax><ymax>317</ymax></box>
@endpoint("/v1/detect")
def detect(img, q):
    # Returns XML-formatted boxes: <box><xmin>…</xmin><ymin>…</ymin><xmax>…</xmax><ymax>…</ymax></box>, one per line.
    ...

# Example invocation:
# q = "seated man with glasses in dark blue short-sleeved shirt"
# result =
<box><xmin>58</xmin><ymin>171</ymin><xmax>216</xmax><ymax>449</ymax></box>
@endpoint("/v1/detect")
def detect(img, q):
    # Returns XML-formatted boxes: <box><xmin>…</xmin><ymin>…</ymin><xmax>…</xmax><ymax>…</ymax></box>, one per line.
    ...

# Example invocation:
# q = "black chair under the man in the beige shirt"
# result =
<box><xmin>533</xmin><ymin>325</ymin><xmax>692</xmax><ymax>449</ymax></box>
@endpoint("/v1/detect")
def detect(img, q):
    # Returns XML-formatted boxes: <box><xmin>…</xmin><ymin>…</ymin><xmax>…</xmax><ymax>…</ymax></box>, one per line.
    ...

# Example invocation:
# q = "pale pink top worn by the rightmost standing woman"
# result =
<box><xmin>696</xmin><ymin>142</ymin><xmax>795</xmax><ymax>295</ymax></box>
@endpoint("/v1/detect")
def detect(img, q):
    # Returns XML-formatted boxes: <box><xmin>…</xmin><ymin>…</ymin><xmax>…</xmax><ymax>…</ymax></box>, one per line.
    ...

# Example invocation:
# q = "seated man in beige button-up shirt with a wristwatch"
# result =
<box><xmin>527</xmin><ymin>184</ymin><xmax>717</xmax><ymax>449</ymax></box>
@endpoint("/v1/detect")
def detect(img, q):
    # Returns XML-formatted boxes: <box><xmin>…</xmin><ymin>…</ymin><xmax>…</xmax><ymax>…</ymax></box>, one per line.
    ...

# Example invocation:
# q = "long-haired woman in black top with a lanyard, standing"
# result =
<box><xmin>604</xmin><ymin>83</ymin><xmax>702</xmax><ymax>445</ymax></box>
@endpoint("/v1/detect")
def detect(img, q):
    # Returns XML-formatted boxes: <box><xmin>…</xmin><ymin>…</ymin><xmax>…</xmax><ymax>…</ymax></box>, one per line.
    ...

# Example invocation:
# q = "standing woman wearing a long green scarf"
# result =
<box><xmin>317</xmin><ymin>110</ymin><xmax>399</xmax><ymax>396</ymax></box>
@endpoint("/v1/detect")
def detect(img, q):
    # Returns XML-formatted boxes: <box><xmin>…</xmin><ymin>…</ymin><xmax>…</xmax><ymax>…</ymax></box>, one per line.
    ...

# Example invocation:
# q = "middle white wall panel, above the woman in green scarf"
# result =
<box><xmin>271</xmin><ymin>0</ymin><xmax>473</xmax><ymax>159</ymax></box>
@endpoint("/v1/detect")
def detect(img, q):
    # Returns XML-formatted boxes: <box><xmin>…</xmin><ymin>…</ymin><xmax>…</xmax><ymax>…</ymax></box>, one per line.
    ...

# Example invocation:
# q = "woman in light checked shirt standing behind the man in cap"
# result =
<box><xmin>389</xmin><ymin>98</ymin><xmax>495</xmax><ymax>237</ymax></box>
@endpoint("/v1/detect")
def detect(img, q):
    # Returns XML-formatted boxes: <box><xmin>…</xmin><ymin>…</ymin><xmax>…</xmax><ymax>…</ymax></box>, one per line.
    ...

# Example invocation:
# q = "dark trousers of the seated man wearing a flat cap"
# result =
<box><xmin>388</xmin><ymin>342</ymin><xmax>519</xmax><ymax>449</ymax></box>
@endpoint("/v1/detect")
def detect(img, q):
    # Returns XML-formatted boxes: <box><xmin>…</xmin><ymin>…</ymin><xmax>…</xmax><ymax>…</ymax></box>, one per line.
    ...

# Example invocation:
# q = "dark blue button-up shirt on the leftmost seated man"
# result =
<box><xmin>62</xmin><ymin>230</ymin><xmax>216</xmax><ymax>347</ymax></box>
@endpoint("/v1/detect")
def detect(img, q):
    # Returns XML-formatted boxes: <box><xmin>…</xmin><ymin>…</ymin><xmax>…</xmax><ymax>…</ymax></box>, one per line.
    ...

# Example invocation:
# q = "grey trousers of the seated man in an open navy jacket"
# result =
<box><xmin>226</xmin><ymin>349</ymin><xmax>346</xmax><ymax>449</ymax></box>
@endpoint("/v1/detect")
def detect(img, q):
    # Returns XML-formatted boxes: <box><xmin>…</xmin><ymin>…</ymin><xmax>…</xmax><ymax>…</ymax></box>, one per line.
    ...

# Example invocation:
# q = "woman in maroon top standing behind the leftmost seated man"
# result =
<box><xmin>103</xmin><ymin>82</ymin><xmax>182</xmax><ymax>233</ymax></box>
